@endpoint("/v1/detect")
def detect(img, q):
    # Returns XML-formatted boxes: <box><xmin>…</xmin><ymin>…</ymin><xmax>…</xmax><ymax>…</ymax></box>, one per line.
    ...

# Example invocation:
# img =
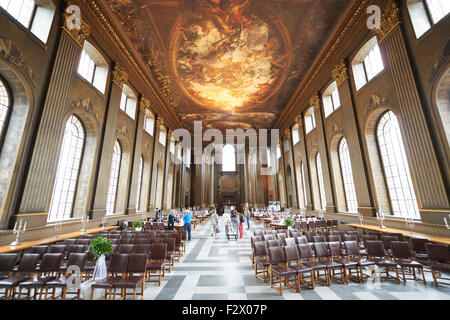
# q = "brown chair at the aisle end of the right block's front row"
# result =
<box><xmin>268</xmin><ymin>247</ymin><xmax>297</xmax><ymax>295</ymax></box>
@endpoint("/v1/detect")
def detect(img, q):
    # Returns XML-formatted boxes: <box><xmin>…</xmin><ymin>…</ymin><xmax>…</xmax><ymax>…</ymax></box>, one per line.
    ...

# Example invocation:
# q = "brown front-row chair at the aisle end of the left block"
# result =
<box><xmin>114</xmin><ymin>252</ymin><xmax>148</xmax><ymax>300</ymax></box>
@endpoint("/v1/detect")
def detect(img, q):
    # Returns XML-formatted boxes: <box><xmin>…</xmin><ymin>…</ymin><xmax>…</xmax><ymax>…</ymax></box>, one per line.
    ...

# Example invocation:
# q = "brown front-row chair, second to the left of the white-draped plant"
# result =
<box><xmin>19</xmin><ymin>253</ymin><xmax>63</xmax><ymax>299</ymax></box>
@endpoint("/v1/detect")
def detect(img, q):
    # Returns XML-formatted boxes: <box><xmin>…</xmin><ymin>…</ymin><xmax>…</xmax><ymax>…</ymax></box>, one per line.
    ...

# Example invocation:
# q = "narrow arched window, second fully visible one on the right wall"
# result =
<box><xmin>339</xmin><ymin>138</ymin><xmax>358</xmax><ymax>213</ymax></box>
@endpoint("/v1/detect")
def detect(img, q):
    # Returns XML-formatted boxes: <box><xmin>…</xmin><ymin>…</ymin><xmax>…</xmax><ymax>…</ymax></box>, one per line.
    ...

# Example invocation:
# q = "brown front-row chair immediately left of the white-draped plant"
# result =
<box><xmin>44</xmin><ymin>253</ymin><xmax>88</xmax><ymax>300</ymax></box>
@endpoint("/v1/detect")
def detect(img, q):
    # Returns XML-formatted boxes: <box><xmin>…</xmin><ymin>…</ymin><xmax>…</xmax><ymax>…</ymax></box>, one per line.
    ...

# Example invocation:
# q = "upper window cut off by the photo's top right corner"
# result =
<box><xmin>407</xmin><ymin>0</ymin><xmax>450</xmax><ymax>38</ymax></box>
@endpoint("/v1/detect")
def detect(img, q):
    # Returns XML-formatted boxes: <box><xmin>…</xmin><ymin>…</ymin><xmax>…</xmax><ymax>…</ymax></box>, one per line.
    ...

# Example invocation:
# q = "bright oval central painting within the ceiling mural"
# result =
<box><xmin>169</xmin><ymin>0</ymin><xmax>292</xmax><ymax>112</ymax></box>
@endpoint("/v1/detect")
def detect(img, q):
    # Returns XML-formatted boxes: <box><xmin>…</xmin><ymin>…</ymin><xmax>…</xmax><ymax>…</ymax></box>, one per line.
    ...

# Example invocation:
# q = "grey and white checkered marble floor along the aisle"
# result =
<box><xmin>138</xmin><ymin>218</ymin><xmax>450</xmax><ymax>300</ymax></box>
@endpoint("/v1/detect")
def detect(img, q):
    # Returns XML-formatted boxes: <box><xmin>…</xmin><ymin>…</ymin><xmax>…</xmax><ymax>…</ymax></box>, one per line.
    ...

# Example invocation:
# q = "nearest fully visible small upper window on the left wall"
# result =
<box><xmin>78</xmin><ymin>41</ymin><xmax>108</xmax><ymax>93</ymax></box>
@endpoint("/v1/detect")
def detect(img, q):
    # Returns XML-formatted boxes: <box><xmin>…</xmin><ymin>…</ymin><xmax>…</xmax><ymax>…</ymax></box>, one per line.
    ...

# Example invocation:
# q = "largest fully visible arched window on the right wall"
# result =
<box><xmin>377</xmin><ymin>111</ymin><xmax>420</xmax><ymax>219</ymax></box>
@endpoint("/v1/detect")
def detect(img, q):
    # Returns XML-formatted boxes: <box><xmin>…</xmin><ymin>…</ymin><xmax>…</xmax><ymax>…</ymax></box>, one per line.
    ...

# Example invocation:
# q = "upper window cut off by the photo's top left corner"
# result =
<box><xmin>0</xmin><ymin>0</ymin><xmax>55</xmax><ymax>43</ymax></box>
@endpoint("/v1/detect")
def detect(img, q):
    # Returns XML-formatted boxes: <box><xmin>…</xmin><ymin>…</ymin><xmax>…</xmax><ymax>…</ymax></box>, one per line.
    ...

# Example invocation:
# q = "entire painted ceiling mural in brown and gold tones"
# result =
<box><xmin>108</xmin><ymin>0</ymin><xmax>350</xmax><ymax>129</ymax></box>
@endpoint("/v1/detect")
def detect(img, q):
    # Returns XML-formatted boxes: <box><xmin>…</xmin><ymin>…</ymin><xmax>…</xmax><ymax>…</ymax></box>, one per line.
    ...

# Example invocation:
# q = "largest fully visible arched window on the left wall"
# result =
<box><xmin>48</xmin><ymin>115</ymin><xmax>85</xmax><ymax>222</ymax></box>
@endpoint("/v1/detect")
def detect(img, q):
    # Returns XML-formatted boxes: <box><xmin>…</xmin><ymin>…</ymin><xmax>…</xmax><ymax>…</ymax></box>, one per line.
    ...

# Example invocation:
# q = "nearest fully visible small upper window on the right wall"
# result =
<box><xmin>352</xmin><ymin>37</ymin><xmax>384</xmax><ymax>90</ymax></box>
